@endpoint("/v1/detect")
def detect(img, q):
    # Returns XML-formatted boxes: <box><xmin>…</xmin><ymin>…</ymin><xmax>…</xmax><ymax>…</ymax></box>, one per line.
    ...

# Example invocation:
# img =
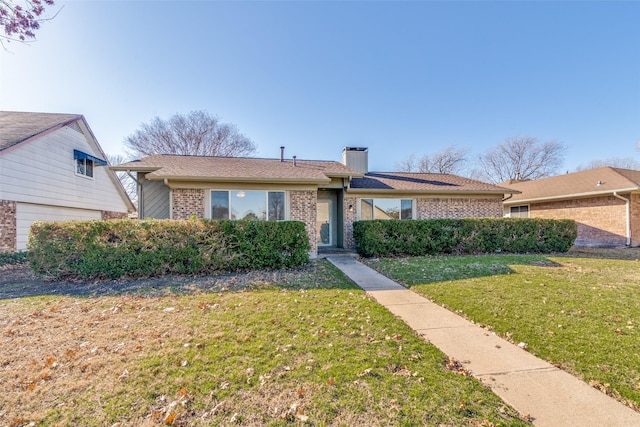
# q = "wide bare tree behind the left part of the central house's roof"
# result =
<box><xmin>124</xmin><ymin>111</ymin><xmax>256</xmax><ymax>157</ymax></box>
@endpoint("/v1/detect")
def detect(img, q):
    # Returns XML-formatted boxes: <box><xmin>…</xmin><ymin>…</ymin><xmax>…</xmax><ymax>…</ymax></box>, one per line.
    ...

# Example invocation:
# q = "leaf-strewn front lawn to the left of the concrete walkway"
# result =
<box><xmin>0</xmin><ymin>261</ymin><xmax>529</xmax><ymax>426</ymax></box>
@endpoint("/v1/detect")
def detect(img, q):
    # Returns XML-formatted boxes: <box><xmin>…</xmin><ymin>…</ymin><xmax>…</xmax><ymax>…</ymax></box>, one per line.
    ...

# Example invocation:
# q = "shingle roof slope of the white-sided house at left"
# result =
<box><xmin>0</xmin><ymin>111</ymin><xmax>82</xmax><ymax>151</ymax></box>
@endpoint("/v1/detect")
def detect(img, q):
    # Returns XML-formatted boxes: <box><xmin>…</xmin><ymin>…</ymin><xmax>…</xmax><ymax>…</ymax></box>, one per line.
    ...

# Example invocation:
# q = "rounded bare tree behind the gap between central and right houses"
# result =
<box><xmin>476</xmin><ymin>136</ymin><xmax>567</xmax><ymax>184</ymax></box>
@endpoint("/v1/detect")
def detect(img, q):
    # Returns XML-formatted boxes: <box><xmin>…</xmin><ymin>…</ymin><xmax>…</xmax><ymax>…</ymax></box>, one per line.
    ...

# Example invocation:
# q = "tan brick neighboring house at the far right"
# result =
<box><xmin>500</xmin><ymin>167</ymin><xmax>640</xmax><ymax>246</ymax></box>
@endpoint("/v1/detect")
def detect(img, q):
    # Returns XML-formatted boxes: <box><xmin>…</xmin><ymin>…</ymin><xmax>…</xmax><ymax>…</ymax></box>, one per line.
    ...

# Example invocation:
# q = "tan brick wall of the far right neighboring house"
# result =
<box><xmin>529</xmin><ymin>196</ymin><xmax>628</xmax><ymax>246</ymax></box>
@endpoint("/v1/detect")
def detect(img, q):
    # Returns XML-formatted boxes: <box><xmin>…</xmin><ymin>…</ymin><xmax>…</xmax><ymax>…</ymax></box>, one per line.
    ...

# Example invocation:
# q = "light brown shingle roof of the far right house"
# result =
<box><xmin>500</xmin><ymin>166</ymin><xmax>640</xmax><ymax>204</ymax></box>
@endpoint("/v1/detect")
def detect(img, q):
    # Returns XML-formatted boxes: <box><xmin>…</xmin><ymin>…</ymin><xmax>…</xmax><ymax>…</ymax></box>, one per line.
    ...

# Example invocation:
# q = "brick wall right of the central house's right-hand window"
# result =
<box><xmin>416</xmin><ymin>197</ymin><xmax>503</xmax><ymax>219</ymax></box>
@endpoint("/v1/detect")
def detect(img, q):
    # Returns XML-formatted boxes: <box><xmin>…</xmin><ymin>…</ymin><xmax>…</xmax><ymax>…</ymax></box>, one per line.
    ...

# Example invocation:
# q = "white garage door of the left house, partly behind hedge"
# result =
<box><xmin>16</xmin><ymin>203</ymin><xmax>102</xmax><ymax>251</ymax></box>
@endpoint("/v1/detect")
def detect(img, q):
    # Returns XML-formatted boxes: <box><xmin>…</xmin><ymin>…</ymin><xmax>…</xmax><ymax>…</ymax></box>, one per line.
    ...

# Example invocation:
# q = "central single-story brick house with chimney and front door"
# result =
<box><xmin>111</xmin><ymin>147</ymin><xmax>514</xmax><ymax>256</ymax></box>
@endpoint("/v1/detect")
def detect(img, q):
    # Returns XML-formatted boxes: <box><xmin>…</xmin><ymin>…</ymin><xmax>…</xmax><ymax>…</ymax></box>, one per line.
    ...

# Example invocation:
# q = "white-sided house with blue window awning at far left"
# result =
<box><xmin>0</xmin><ymin>111</ymin><xmax>135</xmax><ymax>252</ymax></box>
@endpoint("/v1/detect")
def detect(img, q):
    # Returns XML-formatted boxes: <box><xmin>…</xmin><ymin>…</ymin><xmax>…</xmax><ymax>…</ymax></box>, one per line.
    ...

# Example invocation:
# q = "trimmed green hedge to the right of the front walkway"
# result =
<box><xmin>353</xmin><ymin>218</ymin><xmax>578</xmax><ymax>257</ymax></box>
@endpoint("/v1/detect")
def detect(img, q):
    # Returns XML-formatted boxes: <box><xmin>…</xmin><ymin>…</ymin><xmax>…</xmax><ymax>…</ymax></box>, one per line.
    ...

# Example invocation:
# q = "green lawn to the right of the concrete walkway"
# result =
<box><xmin>371</xmin><ymin>250</ymin><xmax>640</xmax><ymax>409</ymax></box>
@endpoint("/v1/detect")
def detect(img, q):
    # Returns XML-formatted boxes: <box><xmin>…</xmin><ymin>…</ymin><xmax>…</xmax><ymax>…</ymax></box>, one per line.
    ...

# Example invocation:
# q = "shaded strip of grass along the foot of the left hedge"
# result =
<box><xmin>0</xmin><ymin>260</ymin><xmax>359</xmax><ymax>300</ymax></box>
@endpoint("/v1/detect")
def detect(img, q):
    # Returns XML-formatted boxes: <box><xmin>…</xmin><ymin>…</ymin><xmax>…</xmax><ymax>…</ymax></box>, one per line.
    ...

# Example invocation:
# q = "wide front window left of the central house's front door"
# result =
<box><xmin>211</xmin><ymin>190</ymin><xmax>285</xmax><ymax>221</ymax></box>
